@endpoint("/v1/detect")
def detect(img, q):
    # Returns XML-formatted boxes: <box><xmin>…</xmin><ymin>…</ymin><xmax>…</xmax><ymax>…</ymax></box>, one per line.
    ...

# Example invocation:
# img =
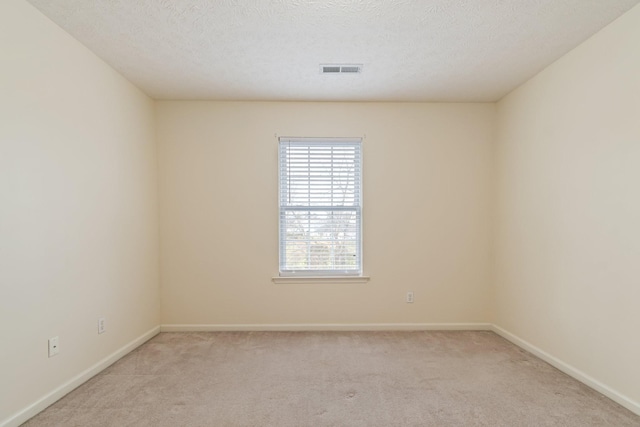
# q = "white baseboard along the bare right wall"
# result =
<box><xmin>491</xmin><ymin>325</ymin><xmax>640</xmax><ymax>415</ymax></box>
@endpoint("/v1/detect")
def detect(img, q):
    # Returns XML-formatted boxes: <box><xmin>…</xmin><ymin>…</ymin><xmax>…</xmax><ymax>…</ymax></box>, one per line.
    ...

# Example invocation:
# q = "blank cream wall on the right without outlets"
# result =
<box><xmin>495</xmin><ymin>6</ymin><xmax>640</xmax><ymax>410</ymax></box>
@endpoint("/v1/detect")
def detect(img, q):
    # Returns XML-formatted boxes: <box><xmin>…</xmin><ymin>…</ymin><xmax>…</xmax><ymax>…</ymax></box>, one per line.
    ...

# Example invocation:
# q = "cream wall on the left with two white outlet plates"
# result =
<box><xmin>0</xmin><ymin>0</ymin><xmax>159</xmax><ymax>424</ymax></box>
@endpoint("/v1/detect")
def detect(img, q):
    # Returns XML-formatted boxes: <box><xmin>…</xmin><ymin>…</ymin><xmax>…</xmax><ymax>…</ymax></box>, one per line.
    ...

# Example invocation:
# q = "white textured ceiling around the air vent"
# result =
<box><xmin>23</xmin><ymin>0</ymin><xmax>640</xmax><ymax>101</ymax></box>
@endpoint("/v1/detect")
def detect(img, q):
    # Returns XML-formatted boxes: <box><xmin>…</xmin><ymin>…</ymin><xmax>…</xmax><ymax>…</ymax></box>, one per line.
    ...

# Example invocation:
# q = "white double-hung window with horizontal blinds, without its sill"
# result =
<box><xmin>279</xmin><ymin>138</ymin><xmax>362</xmax><ymax>276</ymax></box>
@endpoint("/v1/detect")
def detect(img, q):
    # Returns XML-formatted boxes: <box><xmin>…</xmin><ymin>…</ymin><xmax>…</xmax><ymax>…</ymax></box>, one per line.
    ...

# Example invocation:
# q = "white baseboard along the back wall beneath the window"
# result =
<box><xmin>160</xmin><ymin>323</ymin><xmax>492</xmax><ymax>332</ymax></box>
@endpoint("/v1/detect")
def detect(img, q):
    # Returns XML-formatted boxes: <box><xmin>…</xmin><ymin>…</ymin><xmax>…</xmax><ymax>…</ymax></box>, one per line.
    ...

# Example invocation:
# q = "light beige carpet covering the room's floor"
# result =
<box><xmin>25</xmin><ymin>332</ymin><xmax>640</xmax><ymax>427</ymax></box>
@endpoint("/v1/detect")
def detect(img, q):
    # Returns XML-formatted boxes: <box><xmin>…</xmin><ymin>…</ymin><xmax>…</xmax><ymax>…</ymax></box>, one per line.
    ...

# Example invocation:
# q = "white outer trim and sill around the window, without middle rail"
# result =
<box><xmin>272</xmin><ymin>135</ymin><xmax>362</xmax><ymax>283</ymax></box>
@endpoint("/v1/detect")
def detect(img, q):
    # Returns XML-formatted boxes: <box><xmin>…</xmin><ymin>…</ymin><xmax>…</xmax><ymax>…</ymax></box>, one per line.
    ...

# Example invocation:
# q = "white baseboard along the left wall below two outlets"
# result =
<box><xmin>0</xmin><ymin>326</ymin><xmax>160</xmax><ymax>427</ymax></box>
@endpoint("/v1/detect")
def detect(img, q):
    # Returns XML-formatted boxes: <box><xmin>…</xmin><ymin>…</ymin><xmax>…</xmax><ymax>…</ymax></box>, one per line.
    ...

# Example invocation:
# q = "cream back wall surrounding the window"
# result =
<box><xmin>157</xmin><ymin>102</ymin><xmax>495</xmax><ymax>325</ymax></box>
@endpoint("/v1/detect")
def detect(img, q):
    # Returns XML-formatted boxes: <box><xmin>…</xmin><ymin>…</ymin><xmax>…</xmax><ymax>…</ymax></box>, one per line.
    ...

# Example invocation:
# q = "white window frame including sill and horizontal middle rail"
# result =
<box><xmin>273</xmin><ymin>137</ymin><xmax>368</xmax><ymax>283</ymax></box>
